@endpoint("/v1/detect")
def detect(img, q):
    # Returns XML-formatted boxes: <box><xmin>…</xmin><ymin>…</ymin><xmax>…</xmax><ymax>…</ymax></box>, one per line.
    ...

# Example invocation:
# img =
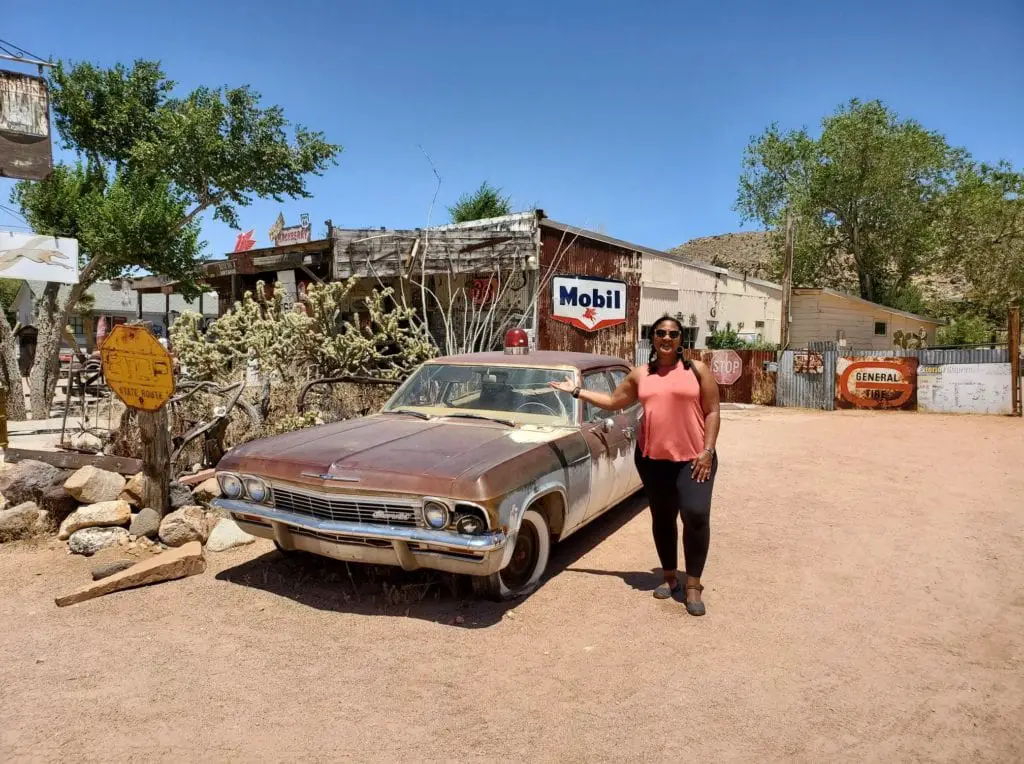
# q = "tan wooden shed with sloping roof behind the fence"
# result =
<box><xmin>790</xmin><ymin>288</ymin><xmax>942</xmax><ymax>350</ymax></box>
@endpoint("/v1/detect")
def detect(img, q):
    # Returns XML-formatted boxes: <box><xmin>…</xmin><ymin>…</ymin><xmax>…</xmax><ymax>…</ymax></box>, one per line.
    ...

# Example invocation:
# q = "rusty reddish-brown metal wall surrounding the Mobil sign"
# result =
<box><xmin>537</xmin><ymin>224</ymin><xmax>641</xmax><ymax>360</ymax></box>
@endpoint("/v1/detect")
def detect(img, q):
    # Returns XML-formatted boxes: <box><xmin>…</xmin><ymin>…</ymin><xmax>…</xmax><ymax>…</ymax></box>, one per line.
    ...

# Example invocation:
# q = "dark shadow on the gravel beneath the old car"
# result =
<box><xmin>216</xmin><ymin>493</ymin><xmax>653</xmax><ymax>629</ymax></box>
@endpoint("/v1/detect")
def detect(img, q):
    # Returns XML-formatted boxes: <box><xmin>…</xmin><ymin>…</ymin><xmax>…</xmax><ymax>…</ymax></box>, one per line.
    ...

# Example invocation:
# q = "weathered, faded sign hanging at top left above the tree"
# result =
<box><xmin>0</xmin><ymin>71</ymin><xmax>53</xmax><ymax>180</ymax></box>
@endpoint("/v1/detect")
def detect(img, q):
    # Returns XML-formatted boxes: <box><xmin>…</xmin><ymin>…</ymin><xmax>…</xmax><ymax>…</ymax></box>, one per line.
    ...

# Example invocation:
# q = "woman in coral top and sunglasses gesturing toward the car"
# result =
<box><xmin>551</xmin><ymin>316</ymin><xmax>721</xmax><ymax>616</ymax></box>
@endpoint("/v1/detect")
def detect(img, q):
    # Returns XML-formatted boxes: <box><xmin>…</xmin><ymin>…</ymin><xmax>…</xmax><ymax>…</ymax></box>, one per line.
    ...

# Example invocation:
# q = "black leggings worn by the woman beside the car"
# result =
<box><xmin>635</xmin><ymin>449</ymin><xmax>718</xmax><ymax>579</ymax></box>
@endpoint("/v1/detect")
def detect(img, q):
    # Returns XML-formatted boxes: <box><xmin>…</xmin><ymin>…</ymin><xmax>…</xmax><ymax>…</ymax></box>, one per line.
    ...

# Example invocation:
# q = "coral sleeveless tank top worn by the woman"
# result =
<box><xmin>637</xmin><ymin>364</ymin><xmax>705</xmax><ymax>462</ymax></box>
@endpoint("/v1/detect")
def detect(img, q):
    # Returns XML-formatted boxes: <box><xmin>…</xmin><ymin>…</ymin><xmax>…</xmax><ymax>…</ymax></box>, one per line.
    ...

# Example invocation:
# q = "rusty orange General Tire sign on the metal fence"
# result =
<box><xmin>836</xmin><ymin>357</ymin><xmax>918</xmax><ymax>410</ymax></box>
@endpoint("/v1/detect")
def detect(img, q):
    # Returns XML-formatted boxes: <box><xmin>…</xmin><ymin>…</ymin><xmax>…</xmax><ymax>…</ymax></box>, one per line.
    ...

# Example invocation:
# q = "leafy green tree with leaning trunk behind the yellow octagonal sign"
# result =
<box><xmin>7</xmin><ymin>60</ymin><xmax>341</xmax><ymax>418</ymax></box>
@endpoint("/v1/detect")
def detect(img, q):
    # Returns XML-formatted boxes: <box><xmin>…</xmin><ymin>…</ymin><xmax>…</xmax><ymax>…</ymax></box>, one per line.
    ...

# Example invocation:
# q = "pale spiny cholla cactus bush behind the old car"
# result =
<box><xmin>171</xmin><ymin>280</ymin><xmax>435</xmax><ymax>382</ymax></box>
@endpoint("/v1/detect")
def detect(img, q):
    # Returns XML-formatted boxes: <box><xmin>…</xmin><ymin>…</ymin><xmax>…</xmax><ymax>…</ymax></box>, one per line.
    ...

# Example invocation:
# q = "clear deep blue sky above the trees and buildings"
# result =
<box><xmin>0</xmin><ymin>0</ymin><xmax>1024</xmax><ymax>256</ymax></box>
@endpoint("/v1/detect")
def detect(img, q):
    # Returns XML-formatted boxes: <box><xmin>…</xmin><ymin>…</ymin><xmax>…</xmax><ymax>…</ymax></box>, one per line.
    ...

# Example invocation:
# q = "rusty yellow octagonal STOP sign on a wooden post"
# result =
<box><xmin>99</xmin><ymin>324</ymin><xmax>174</xmax><ymax>411</ymax></box>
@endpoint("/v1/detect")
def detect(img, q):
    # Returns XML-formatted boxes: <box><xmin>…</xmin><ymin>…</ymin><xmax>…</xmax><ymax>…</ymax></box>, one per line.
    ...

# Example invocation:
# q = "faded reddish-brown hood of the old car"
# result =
<box><xmin>218</xmin><ymin>415</ymin><xmax>565</xmax><ymax>496</ymax></box>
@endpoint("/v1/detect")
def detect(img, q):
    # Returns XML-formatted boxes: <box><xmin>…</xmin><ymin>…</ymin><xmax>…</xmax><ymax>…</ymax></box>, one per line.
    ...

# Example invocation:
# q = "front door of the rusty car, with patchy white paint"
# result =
<box><xmin>581</xmin><ymin>370</ymin><xmax>633</xmax><ymax>519</ymax></box>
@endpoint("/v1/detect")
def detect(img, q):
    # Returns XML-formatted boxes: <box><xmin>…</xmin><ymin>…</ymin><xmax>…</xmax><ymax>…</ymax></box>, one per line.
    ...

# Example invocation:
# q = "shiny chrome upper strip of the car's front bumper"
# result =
<box><xmin>211</xmin><ymin>499</ymin><xmax>506</xmax><ymax>552</ymax></box>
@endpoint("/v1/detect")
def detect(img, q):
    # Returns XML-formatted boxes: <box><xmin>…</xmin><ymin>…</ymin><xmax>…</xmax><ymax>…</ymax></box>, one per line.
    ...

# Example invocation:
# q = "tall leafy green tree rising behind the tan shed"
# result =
<box><xmin>736</xmin><ymin>99</ymin><xmax>969</xmax><ymax>306</ymax></box>
